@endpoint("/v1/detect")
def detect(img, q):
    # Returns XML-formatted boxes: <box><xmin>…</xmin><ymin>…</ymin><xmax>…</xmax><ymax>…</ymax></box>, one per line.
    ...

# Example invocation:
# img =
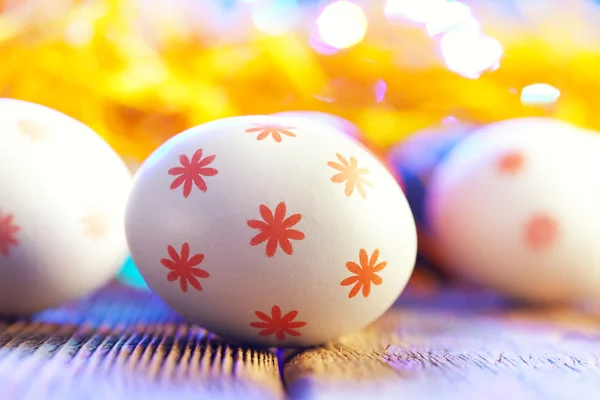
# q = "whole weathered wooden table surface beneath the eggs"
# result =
<box><xmin>0</xmin><ymin>276</ymin><xmax>600</xmax><ymax>400</ymax></box>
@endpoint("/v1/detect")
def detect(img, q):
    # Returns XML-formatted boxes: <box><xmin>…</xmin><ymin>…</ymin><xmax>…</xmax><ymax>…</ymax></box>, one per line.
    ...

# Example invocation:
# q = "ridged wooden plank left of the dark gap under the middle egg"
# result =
<box><xmin>0</xmin><ymin>285</ymin><xmax>285</xmax><ymax>400</ymax></box>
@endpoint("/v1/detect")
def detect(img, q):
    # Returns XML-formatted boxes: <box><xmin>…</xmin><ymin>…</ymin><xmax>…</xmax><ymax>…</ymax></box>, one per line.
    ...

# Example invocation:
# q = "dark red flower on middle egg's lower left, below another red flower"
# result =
<box><xmin>160</xmin><ymin>242</ymin><xmax>210</xmax><ymax>293</ymax></box>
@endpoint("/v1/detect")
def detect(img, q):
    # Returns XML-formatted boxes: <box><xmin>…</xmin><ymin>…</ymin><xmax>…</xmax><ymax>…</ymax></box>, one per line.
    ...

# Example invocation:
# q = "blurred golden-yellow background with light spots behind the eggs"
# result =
<box><xmin>0</xmin><ymin>0</ymin><xmax>600</xmax><ymax>161</ymax></box>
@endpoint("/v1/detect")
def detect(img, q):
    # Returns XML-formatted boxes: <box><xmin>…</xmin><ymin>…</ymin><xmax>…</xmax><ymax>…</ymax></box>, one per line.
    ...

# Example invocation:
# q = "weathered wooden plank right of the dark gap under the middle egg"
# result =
<box><xmin>284</xmin><ymin>291</ymin><xmax>600</xmax><ymax>400</ymax></box>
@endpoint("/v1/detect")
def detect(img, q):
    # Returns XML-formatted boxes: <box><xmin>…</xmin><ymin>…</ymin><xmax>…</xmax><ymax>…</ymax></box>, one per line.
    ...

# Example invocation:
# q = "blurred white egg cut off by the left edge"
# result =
<box><xmin>0</xmin><ymin>99</ymin><xmax>131</xmax><ymax>314</ymax></box>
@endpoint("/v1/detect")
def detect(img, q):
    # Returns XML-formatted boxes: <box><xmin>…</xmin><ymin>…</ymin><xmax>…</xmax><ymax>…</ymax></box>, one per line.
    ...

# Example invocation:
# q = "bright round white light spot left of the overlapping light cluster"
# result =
<box><xmin>316</xmin><ymin>0</ymin><xmax>368</xmax><ymax>49</ymax></box>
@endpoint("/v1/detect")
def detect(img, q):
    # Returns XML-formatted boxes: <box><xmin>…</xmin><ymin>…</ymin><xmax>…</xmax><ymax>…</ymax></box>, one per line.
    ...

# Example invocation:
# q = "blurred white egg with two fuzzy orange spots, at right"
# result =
<box><xmin>426</xmin><ymin>118</ymin><xmax>600</xmax><ymax>301</ymax></box>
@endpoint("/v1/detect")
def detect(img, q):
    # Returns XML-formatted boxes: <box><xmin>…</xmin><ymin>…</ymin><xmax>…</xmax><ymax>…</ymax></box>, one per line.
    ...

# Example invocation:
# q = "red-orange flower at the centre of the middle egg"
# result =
<box><xmin>248</xmin><ymin>202</ymin><xmax>304</xmax><ymax>257</ymax></box>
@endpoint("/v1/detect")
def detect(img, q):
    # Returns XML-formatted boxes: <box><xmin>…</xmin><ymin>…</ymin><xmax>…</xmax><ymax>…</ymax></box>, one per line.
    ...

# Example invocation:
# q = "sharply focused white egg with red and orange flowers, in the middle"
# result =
<box><xmin>126</xmin><ymin>116</ymin><xmax>416</xmax><ymax>347</ymax></box>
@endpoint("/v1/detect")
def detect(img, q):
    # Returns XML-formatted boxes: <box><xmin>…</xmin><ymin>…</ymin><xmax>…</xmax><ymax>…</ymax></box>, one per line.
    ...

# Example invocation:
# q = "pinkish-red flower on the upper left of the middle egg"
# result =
<box><xmin>169</xmin><ymin>149</ymin><xmax>219</xmax><ymax>198</ymax></box>
